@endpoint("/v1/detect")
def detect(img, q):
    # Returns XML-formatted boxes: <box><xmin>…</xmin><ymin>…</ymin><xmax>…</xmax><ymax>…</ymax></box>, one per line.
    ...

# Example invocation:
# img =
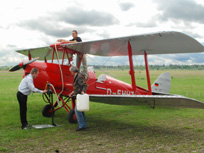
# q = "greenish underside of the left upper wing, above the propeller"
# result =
<box><xmin>17</xmin><ymin>46</ymin><xmax>63</xmax><ymax>60</ymax></box>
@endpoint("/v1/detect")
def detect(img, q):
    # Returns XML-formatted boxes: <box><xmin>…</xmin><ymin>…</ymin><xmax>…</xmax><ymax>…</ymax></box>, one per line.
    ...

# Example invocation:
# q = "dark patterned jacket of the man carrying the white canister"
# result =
<box><xmin>73</xmin><ymin>73</ymin><xmax>88</xmax><ymax>96</ymax></box>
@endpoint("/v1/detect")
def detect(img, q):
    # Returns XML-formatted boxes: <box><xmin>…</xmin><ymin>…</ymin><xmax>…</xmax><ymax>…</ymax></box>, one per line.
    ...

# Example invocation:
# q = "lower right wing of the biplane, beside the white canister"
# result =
<box><xmin>89</xmin><ymin>95</ymin><xmax>204</xmax><ymax>109</ymax></box>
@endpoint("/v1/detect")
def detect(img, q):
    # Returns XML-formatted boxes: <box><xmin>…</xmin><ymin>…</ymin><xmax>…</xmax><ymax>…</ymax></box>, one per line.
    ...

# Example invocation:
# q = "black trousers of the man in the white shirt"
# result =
<box><xmin>17</xmin><ymin>91</ymin><xmax>28</xmax><ymax>128</ymax></box>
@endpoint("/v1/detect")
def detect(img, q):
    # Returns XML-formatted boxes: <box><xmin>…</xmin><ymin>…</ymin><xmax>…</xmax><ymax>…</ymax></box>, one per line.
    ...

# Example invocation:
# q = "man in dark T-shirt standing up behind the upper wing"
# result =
<box><xmin>57</xmin><ymin>30</ymin><xmax>88</xmax><ymax>76</ymax></box>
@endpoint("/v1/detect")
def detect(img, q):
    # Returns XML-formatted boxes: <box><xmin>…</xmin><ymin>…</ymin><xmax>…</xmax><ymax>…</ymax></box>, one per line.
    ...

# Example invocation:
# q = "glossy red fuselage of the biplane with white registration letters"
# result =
<box><xmin>24</xmin><ymin>62</ymin><xmax>149</xmax><ymax>96</ymax></box>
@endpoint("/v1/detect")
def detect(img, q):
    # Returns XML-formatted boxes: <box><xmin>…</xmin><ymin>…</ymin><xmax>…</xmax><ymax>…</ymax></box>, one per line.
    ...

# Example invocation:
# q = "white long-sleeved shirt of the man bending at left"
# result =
<box><xmin>18</xmin><ymin>74</ymin><xmax>43</xmax><ymax>95</ymax></box>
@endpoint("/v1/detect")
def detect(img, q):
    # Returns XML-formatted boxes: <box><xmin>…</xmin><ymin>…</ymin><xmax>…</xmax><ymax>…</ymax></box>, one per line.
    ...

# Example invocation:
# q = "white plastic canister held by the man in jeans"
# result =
<box><xmin>76</xmin><ymin>94</ymin><xmax>89</xmax><ymax>112</ymax></box>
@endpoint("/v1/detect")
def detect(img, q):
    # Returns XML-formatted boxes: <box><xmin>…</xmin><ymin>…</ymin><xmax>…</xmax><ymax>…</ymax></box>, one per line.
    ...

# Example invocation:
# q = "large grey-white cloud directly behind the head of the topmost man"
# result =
<box><xmin>18</xmin><ymin>7</ymin><xmax>119</xmax><ymax>38</ymax></box>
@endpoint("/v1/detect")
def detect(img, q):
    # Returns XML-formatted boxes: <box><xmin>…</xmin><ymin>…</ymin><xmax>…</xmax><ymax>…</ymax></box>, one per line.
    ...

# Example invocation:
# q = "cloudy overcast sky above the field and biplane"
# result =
<box><xmin>0</xmin><ymin>0</ymin><xmax>204</xmax><ymax>66</ymax></box>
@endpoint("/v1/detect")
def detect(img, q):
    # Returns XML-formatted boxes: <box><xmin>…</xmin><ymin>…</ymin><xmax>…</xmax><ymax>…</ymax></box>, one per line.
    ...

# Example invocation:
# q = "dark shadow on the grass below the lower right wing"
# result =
<box><xmin>82</xmin><ymin>112</ymin><xmax>202</xmax><ymax>144</ymax></box>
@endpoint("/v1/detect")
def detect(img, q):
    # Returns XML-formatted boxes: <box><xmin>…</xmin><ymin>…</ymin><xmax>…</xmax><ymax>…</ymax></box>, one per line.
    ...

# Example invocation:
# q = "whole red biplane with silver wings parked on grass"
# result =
<box><xmin>10</xmin><ymin>32</ymin><xmax>204</xmax><ymax>123</ymax></box>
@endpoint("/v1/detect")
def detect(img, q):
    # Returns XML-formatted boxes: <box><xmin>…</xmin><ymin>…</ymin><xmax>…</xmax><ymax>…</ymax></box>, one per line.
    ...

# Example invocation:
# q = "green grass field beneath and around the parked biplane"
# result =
<box><xmin>0</xmin><ymin>70</ymin><xmax>204</xmax><ymax>153</ymax></box>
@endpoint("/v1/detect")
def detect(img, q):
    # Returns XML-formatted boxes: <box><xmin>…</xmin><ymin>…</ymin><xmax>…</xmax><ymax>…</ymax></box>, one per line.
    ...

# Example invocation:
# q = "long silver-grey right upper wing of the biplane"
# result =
<box><xmin>61</xmin><ymin>31</ymin><xmax>204</xmax><ymax>56</ymax></box>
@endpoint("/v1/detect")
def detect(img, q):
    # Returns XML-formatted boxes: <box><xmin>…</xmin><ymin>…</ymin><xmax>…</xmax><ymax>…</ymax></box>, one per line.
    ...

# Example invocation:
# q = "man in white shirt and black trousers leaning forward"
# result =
<box><xmin>17</xmin><ymin>68</ymin><xmax>47</xmax><ymax>129</ymax></box>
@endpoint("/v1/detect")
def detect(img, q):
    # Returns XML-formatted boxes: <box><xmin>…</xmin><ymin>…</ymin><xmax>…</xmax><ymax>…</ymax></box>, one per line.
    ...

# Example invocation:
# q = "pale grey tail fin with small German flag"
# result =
<box><xmin>152</xmin><ymin>72</ymin><xmax>171</xmax><ymax>93</ymax></box>
